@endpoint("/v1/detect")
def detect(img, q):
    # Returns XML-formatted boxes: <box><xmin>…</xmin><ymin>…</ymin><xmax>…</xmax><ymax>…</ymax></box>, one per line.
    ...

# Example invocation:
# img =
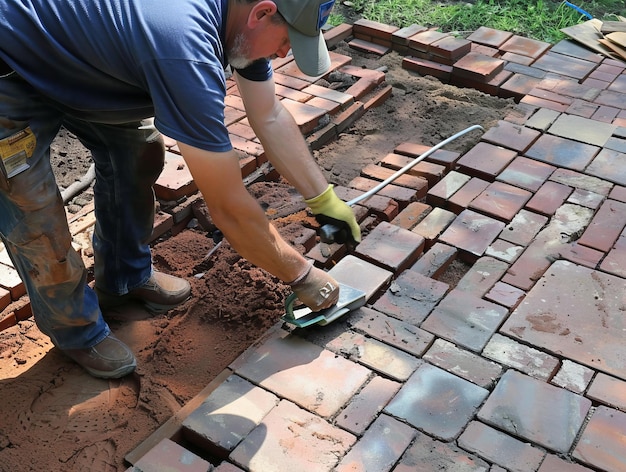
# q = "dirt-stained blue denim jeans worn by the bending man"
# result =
<box><xmin>0</xmin><ymin>73</ymin><xmax>164</xmax><ymax>349</ymax></box>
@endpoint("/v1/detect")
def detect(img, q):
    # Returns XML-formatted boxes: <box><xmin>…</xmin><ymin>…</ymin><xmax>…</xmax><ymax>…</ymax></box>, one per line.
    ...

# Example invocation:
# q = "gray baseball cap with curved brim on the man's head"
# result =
<box><xmin>273</xmin><ymin>0</ymin><xmax>335</xmax><ymax>77</ymax></box>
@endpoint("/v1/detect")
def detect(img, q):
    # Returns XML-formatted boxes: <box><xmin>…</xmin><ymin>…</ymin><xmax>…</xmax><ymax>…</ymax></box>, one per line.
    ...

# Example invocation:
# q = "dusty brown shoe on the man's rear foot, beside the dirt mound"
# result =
<box><xmin>95</xmin><ymin>271</ymin><xmax>191</xmax><ymax>315</ymax></box>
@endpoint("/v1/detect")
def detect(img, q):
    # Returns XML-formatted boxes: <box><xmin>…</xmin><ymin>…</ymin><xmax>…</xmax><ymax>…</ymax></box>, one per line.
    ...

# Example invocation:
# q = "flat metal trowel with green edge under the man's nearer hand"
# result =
<box><xmin>282</xmin><ymin>283</ymin><xmax>367</xmax><ymax>328</ymax></box>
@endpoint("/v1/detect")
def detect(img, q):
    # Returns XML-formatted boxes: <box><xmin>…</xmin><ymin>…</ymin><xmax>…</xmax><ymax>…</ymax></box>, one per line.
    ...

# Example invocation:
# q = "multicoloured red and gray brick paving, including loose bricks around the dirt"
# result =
<box><xmin>123</xmin><ymin>22</ymin><xmax>626</xmax><ymax>472</ymax></box>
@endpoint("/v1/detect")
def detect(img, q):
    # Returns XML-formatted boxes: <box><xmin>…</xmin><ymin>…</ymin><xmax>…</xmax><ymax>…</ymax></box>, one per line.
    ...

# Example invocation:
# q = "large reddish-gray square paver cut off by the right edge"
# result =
<box><xmin>501</xmin><ymin>261</ymin><xmax>626</xmax><ymax>380</ymax></box>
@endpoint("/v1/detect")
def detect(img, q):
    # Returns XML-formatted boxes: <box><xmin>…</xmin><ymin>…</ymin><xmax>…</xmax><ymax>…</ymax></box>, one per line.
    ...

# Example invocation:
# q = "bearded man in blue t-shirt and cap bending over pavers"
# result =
<box><xmin>0</xmin><ymin>0</ymin><xmax>360</xmax><ymax>378</ymax></box>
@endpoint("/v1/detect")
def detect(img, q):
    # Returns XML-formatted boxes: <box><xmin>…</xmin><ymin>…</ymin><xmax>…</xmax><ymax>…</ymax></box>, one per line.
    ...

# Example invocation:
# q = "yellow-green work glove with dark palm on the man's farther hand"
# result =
<box><xmin>304</xmin><ymin>184</ymin><xmax>361</xmax><ymax>243</ymax></box>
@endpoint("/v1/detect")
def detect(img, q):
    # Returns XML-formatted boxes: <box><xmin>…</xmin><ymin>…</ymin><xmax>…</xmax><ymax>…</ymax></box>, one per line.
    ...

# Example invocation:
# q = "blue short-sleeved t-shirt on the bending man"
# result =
<box><xmin>0</xmin><ymin>0</ymin><xmax>272</xmax><ymax>152</ymax></box>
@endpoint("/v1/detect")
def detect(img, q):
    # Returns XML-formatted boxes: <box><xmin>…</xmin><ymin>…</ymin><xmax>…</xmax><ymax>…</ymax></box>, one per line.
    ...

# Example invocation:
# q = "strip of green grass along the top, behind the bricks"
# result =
<box><xmin>330</xmin><ymin>0</ymin><xmax>626</xmax><ymax>43</ymax></box>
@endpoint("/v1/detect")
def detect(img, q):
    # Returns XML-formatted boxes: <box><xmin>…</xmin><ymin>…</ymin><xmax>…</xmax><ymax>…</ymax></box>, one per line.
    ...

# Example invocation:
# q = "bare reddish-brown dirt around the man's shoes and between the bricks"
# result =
<box><xmin>0</xmin><ymin>36</ymin><xmax>513</xmax><ymax>472</ymax></box>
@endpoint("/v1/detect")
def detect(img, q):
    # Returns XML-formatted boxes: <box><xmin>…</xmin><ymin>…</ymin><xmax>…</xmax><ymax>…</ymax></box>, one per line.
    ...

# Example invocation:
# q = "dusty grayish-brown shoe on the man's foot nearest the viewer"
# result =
<box><xmin>62</xmin><ymin>333</ymin><xmax>137</xmax><ymax>379</ymax></box>
